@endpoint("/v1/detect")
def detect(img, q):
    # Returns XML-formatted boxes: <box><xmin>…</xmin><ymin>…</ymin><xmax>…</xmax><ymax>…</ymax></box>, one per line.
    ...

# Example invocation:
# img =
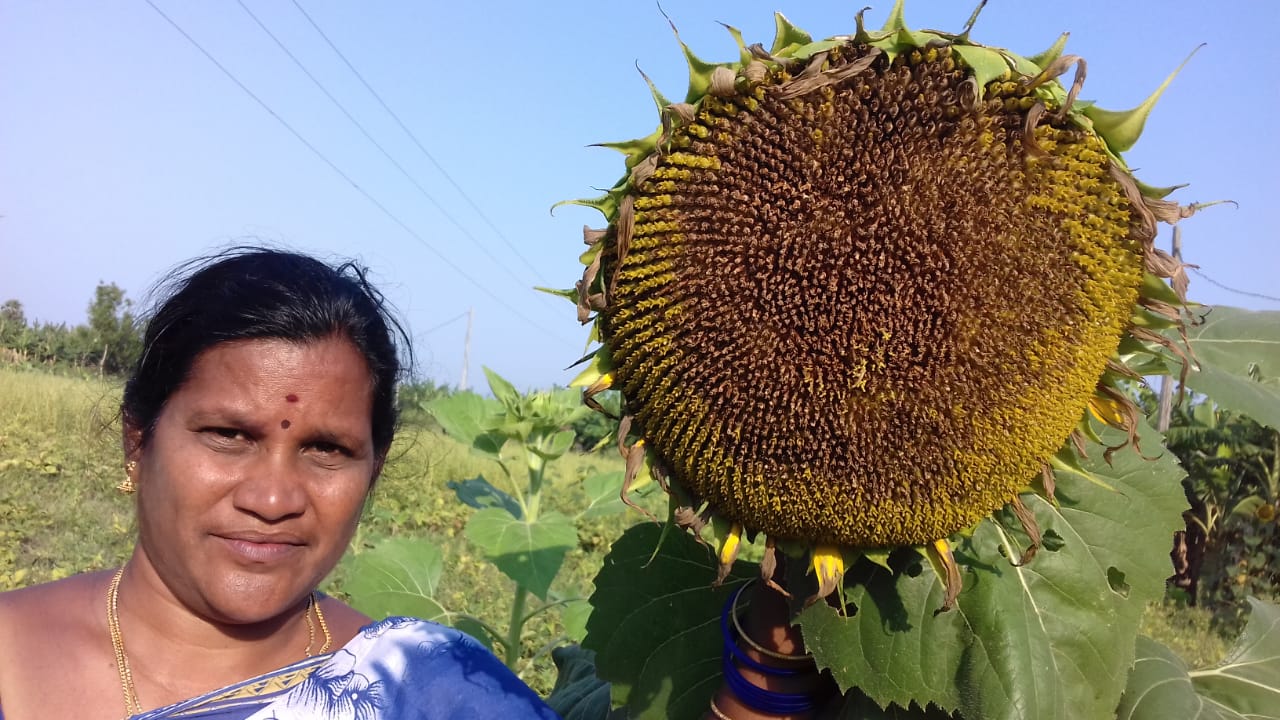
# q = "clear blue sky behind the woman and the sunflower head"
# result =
<box><xmin>0</xmin><ymin>0</ymin><xmax>1280</xmax><ymax>388</ymax></box>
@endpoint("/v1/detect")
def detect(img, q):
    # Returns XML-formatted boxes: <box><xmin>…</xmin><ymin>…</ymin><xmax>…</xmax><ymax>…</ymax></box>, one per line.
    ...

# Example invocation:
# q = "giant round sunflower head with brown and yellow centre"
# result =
<box><xmin>565</xmin><ymin>4</ymin><xmax>1185</xmax><ymax>599</ymax></box>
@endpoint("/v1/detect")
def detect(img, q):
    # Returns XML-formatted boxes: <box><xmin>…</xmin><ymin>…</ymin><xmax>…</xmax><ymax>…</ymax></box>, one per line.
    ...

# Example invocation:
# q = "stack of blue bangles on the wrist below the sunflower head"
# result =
<box><xmin>712</xmin><ymin>583</ymin><xmax>819</xmax><ymax>720</ymax></box>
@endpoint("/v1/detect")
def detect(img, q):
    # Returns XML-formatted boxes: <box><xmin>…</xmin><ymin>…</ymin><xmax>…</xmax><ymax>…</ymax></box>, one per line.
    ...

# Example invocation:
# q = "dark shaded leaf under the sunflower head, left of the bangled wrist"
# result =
<box><xmin>582</xmin><ymin>523</ymin><xmax>759</xmax><ymax>720</ymax></box>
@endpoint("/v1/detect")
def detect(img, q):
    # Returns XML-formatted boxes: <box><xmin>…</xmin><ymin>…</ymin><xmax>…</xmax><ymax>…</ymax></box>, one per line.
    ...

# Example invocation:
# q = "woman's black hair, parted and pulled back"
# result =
<box><xmin>120</xmin><ymin>247</ymin><xmax>411</xmax><ymax>455</ymax></box>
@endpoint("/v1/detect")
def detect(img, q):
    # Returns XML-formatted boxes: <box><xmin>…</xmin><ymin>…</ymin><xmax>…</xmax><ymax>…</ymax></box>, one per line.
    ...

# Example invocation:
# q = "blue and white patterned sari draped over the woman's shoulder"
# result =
<box><xmin>8</xmin><ymin>618</ymin><xmax>557</xmax><ymax>720</ymax></box>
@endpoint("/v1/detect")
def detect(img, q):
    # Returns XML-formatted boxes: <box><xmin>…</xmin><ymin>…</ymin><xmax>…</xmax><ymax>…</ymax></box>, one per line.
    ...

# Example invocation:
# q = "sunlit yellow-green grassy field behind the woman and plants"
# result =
<box><xmin>0</xmin><ymin>368</ymin><xmax>1226</xmax><ymax>693</ymax></box>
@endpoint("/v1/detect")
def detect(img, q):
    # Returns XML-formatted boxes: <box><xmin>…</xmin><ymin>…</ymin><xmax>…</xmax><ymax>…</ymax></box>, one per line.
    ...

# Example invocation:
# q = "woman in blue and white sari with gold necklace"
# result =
<box><xmin>0</xmin><ymin>250</ymin><xmax>556</xmax><ymax>720</ymax></box>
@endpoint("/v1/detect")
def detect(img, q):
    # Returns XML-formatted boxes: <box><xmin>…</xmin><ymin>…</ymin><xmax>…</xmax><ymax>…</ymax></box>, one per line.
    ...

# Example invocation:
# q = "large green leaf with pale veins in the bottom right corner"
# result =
<box><xmin>1116</xmin><ymin>598</ymin><xmax>1280</xmax><ymax>720</ymax></box>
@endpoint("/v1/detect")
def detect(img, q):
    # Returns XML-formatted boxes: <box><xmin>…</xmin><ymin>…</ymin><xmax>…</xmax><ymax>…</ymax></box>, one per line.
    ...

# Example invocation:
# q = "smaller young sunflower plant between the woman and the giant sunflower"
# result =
<box><xmin>346</xmin><ymin>368</ymin><xmax>632</xmax><ymax>670</ymax></box>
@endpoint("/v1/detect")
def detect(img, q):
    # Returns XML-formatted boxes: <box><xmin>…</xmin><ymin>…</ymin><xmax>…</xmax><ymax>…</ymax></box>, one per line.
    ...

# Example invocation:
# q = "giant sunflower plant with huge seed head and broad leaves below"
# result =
<box><xmin>564</xmin><ymin>1</ymin><xmax>1280</xmax><ymax>719</ymax></box>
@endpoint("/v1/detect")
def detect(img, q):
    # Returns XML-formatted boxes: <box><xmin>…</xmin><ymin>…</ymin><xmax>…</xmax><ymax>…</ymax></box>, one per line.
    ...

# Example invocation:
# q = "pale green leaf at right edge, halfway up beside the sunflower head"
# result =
<box><xmin>1187</xmin><ymin>306</ymin><xmax>1280</xmax><ymax>429</ymax></box>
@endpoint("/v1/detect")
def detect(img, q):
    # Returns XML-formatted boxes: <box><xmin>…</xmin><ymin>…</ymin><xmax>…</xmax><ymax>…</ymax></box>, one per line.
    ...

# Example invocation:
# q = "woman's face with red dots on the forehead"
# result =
<box><xmin>127</xmin><ymin>337</ymin><xmax>381</xmax><ymax>624</ymax></box>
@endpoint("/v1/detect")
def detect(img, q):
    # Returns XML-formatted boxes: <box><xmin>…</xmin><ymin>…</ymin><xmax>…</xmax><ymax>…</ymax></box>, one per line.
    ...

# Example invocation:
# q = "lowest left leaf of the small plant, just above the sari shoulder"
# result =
<box><xmin>343</xmin><ymin>538</ymin><xmax>453</xmax><ymax>623</ymax></box>
